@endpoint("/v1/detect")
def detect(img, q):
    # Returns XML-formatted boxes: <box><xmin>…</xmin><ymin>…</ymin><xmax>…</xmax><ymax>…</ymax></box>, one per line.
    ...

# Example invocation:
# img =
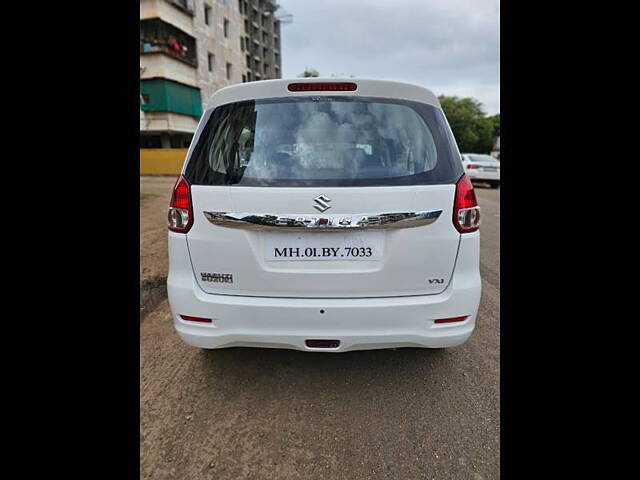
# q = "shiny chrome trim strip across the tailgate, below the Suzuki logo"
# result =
<box><xmin>203</xmin><ymin>210</ymin><xmax>442</xmax><ymax>232</ymax></box>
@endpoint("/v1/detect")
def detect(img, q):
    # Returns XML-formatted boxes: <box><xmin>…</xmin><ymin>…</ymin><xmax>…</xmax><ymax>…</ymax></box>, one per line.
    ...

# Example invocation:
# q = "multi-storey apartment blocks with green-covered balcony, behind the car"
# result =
<box><xmin>140</xmin><ymin>0</ymin><xmax>282</xmax><ymax>148</ymax></box>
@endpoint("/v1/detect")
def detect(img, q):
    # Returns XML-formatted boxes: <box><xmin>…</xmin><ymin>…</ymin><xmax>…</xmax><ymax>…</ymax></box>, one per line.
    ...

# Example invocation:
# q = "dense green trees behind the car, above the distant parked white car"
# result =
<box><xmin>438</xmin><ymin>95</ymin><xmax>500</xmax><ymax>153</ymax></box>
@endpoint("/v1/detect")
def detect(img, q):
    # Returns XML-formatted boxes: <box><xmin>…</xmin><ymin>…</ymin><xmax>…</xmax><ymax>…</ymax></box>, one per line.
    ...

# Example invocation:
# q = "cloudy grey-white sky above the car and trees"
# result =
<box><xmin>278</xmin><ymin>0</ymin><xmax>500</xmax><ymax>115</ymax></box>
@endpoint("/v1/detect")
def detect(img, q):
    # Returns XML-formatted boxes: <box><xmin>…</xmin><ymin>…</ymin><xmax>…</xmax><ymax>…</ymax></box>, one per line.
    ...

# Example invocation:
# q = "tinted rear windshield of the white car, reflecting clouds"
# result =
<box><xmin>185</xmin><ymin>96</ymin><xmax>463</xmax><ymax>187</ymax></box>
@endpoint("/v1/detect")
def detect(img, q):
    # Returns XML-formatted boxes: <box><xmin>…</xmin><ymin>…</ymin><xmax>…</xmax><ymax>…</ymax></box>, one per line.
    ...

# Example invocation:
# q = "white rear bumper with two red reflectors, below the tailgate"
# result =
<box><xmin>167</xmin><ymin>233</ymin><xmax>481</xmax><ymax>352</ymax></box>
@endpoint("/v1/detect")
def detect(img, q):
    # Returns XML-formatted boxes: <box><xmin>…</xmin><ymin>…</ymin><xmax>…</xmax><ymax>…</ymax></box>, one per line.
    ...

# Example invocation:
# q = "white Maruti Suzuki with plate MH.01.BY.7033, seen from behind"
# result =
<box><xmin>167</xmin><ymin>78</ymin><xmax>481</xmax><ymax>352</ymax></box>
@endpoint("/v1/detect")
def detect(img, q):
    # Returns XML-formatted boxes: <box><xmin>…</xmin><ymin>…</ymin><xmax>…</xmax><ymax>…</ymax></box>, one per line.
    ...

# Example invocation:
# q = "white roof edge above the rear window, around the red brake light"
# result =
<box><xmin>207</xmin><ymin>77</ymin><xmax>441</xmax><ymax>110</ymax></box>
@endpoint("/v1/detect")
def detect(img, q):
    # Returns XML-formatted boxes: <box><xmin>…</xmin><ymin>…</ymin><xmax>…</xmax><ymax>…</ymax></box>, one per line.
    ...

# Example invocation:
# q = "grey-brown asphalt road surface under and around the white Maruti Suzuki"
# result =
<box><xmin>140</xmin><ymin>179</ymin><xmax>500</xmax><ymax>479</ymax></box>
